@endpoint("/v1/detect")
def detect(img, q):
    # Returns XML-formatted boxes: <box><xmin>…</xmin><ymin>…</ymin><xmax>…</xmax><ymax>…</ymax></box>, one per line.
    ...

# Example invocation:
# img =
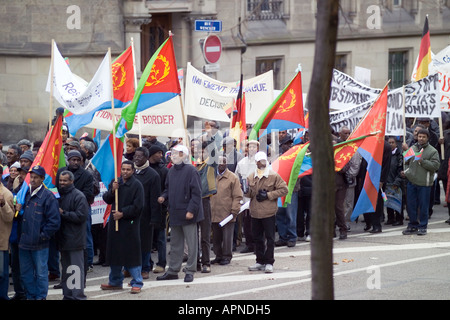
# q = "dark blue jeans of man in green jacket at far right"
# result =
<box><xmin>406</xmin><ymin>182</ymin><xmax>432</xmax><ymax>229</ymax></box>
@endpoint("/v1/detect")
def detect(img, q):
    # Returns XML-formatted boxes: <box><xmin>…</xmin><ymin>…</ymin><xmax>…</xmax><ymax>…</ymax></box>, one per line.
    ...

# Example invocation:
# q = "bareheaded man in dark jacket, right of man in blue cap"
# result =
<box><xmin>56</xmin><ymin>170</ymin><xmax>89</xmax><ymax>300</ymax></box>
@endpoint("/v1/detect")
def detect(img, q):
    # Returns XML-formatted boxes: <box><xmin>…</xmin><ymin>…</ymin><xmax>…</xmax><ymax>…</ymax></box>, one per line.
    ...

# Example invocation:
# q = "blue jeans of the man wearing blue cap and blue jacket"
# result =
<box><xmin>19</xmin><ymin>248</ymin><xmax>49</xmax><ymax>300</ymax></box>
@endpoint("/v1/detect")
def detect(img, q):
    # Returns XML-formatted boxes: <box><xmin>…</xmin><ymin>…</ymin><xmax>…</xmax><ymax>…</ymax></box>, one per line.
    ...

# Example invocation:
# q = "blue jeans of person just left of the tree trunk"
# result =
<box><xmin>276</xmin><ymin>192</ymin><xmax>298</xmax><ymax>241</ymax></box>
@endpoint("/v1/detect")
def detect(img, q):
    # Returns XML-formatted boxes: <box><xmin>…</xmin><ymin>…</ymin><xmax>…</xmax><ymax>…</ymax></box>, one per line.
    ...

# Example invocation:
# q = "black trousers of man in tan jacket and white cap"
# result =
<box><xmin>252</xmin><ymin>215</ymin><xmax>275</xmax><ymax>264</ymax></box>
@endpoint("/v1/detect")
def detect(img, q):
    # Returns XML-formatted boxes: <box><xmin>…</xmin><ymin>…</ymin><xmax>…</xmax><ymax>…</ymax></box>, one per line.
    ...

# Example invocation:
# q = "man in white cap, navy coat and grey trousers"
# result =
<box><xmin>156</xmin><ymin>144</ymin><xmax>204</xmax><ymax>282</ymax></box>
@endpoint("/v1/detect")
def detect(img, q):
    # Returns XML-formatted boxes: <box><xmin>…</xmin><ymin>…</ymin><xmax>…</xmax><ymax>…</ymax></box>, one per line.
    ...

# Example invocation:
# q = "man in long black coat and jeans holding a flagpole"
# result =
<box><xmin>100</xmin><ymin>160</ymin><xmax>144</xmax><ymax>293</ymax></box>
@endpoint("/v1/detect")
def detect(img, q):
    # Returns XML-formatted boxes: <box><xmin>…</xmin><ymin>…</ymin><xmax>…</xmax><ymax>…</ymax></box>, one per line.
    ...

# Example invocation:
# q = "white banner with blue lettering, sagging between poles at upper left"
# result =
<box><xmin>46</xmin><ymin>43</ymin><xmax>112</xmax><ymax>114</ymax></box>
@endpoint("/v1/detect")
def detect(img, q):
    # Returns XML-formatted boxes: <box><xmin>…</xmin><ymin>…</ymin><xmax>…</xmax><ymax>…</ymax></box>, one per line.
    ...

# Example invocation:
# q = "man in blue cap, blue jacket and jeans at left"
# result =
<box><xmin>16</xmin><ymin>166</ymin><xmax>61</xmax><ymax>300</ymax></box>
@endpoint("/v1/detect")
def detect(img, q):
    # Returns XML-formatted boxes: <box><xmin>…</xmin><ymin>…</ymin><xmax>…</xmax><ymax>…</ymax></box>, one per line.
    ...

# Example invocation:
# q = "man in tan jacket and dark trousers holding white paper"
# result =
<box><xmin>211</xmin><ymin>156</ymin><xmax>243</xmax><ymax>265</ymax></box>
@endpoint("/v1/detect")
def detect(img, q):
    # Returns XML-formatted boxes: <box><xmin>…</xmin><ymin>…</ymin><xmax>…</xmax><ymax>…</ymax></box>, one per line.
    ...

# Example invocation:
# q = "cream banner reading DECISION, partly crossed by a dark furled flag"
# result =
<box><xmin>185</xmin><ymin>63</ymin><xmax>274</xmax><ymax>124</ymax></box>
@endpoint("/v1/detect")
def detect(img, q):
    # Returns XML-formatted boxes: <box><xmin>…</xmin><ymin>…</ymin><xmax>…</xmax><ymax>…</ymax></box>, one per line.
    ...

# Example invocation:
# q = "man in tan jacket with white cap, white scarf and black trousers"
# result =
<box><xmin>245</xmin><ymin>151</ymin><xmax>288</xmax><ymax>273</ymax></box>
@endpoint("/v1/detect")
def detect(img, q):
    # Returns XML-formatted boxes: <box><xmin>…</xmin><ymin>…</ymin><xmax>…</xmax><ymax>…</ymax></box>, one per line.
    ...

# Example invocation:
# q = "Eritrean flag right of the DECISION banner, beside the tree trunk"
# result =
<box><xmin>249</xmin><ymin>71</ymin><xmax>305</xmax><ymax>140</ymax></box>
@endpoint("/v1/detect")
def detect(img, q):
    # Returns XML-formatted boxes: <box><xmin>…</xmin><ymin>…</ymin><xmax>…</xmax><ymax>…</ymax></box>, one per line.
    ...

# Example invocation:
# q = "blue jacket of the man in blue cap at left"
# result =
<box><xmin>19</xmin><ymin>186</ymin><xmax>61</xmax><ymax>250</ymax></box>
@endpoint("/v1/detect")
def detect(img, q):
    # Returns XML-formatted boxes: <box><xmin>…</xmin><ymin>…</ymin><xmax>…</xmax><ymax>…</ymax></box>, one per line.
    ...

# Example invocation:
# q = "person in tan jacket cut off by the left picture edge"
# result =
<box><xmin>0</xmin><ymin>165</ymin><xmax>14</xmax><ymax>300</ymax></box>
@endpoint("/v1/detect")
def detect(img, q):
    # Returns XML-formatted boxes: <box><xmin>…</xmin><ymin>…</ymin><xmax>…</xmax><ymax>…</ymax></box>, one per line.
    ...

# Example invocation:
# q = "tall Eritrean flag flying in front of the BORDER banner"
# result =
<box><xmin>116</xmin><ymin>36</ymin><xmax>181</xmax><ymax>138</ymax></box>
